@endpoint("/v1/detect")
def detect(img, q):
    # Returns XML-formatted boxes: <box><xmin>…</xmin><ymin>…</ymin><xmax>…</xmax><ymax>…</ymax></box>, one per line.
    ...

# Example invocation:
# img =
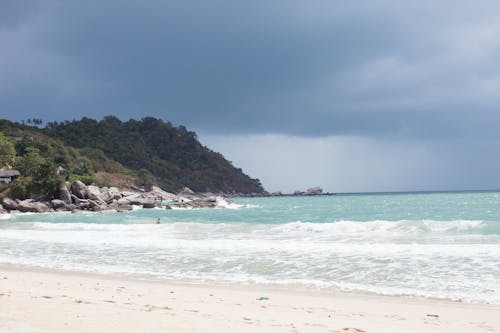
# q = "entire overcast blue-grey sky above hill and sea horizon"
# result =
<box><xmin>0</xmin><ymin>0</ymin><xmax>500</xmax><ymax>192</ymax></box>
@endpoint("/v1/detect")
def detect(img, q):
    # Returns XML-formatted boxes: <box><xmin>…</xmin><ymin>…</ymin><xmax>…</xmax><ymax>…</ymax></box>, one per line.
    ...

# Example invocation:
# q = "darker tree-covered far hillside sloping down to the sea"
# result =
<box><xmin>42</xmin><ymin>116</ymin><xmax>264</xmax><ymax>194</ymax></box>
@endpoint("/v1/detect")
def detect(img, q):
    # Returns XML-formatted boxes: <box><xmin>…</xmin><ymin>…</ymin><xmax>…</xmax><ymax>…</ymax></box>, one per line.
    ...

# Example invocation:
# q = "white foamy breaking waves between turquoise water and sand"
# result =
<box><xmin>0</xmin><ymin>207</ymin><xmax>500</xmax><ymax>304</ymax></box>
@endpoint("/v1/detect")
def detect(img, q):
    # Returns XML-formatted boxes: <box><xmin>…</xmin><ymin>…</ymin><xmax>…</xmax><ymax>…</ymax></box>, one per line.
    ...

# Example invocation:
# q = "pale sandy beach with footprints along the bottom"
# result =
<box><xmin>0</xmin><ymin>265</ymin><xmax>500</xmax><ymax>333</ymax></box>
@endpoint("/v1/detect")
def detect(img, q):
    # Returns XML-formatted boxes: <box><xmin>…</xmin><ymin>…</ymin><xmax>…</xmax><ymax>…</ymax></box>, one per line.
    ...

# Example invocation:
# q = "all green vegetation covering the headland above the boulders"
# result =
<box><xmin>0</xmin><ymin>116</ymin><xmax>264</xmax><ymax>197</ymax></box>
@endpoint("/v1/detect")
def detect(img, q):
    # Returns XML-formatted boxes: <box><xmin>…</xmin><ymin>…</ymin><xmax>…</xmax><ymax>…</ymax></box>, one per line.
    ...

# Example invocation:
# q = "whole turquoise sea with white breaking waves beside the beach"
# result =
<box><xmin>0</xmin><ymin>191</ymin><xmax>500</xmax><ymax>304</ymax></box>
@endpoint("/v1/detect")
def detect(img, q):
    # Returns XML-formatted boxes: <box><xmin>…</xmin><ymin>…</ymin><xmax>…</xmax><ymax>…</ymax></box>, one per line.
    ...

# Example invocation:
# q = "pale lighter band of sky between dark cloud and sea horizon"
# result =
<box><xmin>201</xmin><ymin>134</ymin><xmax>500</xmax><ymax>193</ymax></box>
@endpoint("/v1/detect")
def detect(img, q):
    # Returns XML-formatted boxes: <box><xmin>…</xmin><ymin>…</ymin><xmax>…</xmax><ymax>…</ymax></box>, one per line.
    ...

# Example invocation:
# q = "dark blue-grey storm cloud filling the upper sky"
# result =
<box><xmin>0</xmin><ymin>0</ymin><xmax>500</xmax><ymax>139</ymax></box>
